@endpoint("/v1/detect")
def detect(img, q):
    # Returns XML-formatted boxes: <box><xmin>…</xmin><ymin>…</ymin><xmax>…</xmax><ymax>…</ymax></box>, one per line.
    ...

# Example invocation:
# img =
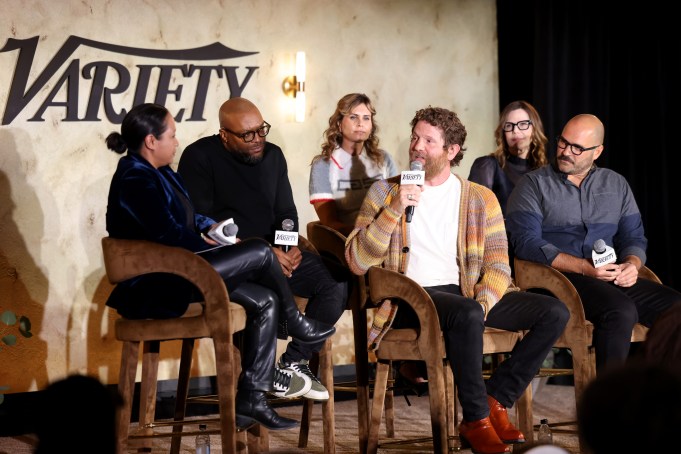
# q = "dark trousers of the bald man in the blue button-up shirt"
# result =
<box><xmin>565</xmin><ymin>273</ymin><xmax>681</xmax><ymax>369</ymax></box>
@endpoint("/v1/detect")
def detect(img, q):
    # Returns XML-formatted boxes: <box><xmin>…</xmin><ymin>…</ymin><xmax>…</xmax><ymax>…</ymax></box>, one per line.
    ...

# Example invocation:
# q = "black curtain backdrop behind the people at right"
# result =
<box><xmin>497</xmin><ymin>0</ymin><xmax>681</xmax><ymax>289</ymax></box>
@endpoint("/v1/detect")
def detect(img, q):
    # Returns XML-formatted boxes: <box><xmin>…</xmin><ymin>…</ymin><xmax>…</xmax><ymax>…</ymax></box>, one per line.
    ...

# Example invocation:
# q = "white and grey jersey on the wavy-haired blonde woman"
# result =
<box><xmin>310</xmin><ymin>147</ymin><xmax>397</xmax><ymax>225</ymax></box>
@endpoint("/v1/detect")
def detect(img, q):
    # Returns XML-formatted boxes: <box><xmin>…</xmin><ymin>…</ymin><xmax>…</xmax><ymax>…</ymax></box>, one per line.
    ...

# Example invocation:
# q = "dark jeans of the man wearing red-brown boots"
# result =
<box><xmin>393</xmin><ymin>285</ymin><xmax>570</xmax><ymax>421</ymax></box>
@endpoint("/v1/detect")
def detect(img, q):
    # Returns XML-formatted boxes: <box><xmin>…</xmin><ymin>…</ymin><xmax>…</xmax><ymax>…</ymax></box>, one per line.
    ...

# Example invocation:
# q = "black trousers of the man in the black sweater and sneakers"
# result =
<box><xmin>283</xmin><ymin>251</ymin><xmax>350</xmax><ymax>362</ymax></box>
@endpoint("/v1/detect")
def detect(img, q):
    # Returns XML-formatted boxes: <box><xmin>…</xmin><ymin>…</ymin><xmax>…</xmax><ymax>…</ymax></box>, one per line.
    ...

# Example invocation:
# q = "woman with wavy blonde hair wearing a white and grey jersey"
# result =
<box><xmin>310</xmin><ymin>93</ymin><xmax>397</xmax><ymax>235</ymax></box>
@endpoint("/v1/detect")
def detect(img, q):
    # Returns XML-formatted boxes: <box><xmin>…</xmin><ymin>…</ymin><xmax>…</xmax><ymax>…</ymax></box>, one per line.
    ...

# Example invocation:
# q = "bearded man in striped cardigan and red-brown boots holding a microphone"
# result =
<box><xmin>345</xmin><ymin>107</ymin><xmax>569</xmax><ymax>454</ymax></box>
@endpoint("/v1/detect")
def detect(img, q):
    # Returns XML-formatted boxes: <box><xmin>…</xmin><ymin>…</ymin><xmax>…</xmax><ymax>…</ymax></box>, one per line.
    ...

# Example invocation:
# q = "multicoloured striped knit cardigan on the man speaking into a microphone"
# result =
<box><xmin>345</xmin><ymin>175</ymin><xmax>518</xmax><ymax>350</ymax></box>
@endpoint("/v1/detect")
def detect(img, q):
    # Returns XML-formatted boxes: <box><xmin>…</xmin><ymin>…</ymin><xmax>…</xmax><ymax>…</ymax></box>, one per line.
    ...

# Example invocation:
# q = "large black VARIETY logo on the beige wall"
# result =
<box><xmin>0</xmin><ymin>36</ymin><xmax>259</xmax><ymax>125</ymax></box>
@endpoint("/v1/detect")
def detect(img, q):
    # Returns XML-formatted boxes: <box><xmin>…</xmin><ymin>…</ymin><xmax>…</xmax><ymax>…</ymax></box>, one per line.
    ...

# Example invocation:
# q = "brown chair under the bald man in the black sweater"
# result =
<box><xmin>298</xmin><ymin>221</ymin><xmax>394</xmax><ymax>453</ymax></box>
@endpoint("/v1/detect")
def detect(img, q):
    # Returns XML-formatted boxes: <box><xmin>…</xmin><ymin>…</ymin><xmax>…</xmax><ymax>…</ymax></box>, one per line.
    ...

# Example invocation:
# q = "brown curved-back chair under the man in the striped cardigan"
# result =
<box><xmin>367</xmin><ymin>267</ymin><xmax>532</xmax><ymax>453</ymax></box>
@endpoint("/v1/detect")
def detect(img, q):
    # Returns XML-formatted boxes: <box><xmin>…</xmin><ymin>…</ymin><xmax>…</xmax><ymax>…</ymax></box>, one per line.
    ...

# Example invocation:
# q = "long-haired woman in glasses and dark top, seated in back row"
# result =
<box><xmin>468</xmin><ymin>101</ymin><xmax>548</xmax><ymax>214</ymax></box>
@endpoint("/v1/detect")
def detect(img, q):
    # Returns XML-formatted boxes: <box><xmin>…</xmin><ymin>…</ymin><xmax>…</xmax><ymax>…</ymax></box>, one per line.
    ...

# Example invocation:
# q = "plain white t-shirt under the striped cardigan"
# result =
<box><xmin>407</xmin><ymin>174</ymin><xmax>461</xmax><ymax>287</ymax></box>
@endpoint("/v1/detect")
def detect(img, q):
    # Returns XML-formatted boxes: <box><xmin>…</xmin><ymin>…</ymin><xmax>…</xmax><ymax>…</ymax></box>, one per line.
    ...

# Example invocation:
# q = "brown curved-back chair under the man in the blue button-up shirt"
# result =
<box><xmin>514</xmin><ymin>258</ymin><xmax>661</xmax><ymax>448</ymax></box>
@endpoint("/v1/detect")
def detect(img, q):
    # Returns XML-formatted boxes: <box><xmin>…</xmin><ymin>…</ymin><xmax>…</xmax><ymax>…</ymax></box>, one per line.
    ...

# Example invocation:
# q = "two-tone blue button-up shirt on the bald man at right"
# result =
<box><xmin>506</xmin><ymin>165</ymin><xmax>648</xmax><ymax>265</ymax></box>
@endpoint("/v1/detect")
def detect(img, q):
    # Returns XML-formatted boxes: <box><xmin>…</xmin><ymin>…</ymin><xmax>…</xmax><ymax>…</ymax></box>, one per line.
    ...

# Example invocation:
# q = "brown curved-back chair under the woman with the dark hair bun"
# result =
<box><xmin>102</xmin><ymin>238</ymin><xmax>258</xmax><ymax>453</ymax></box>
